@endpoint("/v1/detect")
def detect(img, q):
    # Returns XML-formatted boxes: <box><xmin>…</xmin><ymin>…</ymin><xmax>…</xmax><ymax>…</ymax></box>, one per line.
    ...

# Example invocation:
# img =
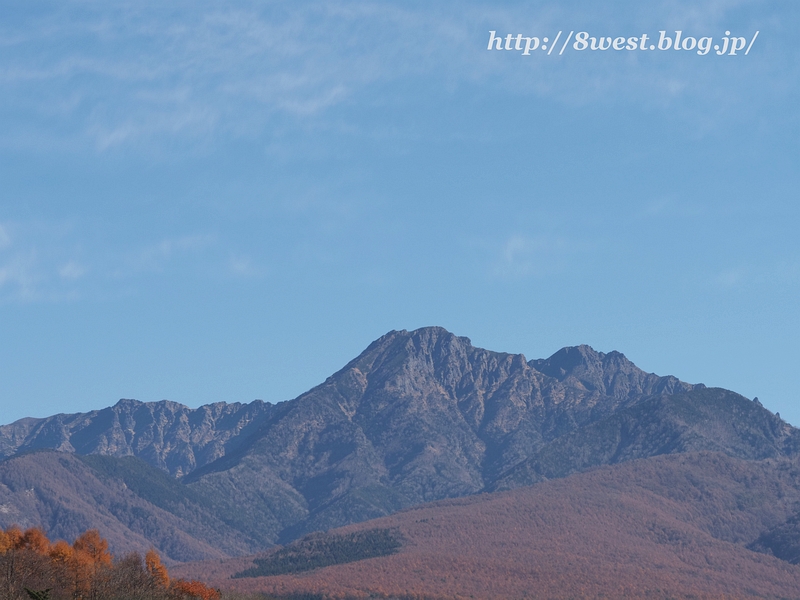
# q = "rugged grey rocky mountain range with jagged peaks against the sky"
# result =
<box><xmin>0</xmin><ymin>327</ymin><xmax>800</xmax><ymax>554</ymax></box>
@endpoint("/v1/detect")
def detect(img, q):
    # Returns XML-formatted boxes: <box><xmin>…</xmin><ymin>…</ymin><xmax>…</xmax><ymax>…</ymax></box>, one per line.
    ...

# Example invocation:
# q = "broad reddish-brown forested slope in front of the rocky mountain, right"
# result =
<box><xmin>174</xmin><ymin>452</ymin><xmax>800</xmax><ymax>598</ymax></box>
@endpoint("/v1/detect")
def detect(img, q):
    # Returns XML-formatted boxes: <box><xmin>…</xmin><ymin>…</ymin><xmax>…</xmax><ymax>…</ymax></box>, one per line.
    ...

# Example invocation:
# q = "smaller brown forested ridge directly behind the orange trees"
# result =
<box><xmin>0</xmin><ymin>451</ymin><xmax>256</xmax><ymax>561</ymax></box>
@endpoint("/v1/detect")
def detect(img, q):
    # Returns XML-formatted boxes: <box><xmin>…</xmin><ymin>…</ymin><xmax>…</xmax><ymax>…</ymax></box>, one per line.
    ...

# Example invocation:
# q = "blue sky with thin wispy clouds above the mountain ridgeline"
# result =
<box><xmin>0</xmin><ymin>0</ymin><xmax>800</xmax><ymax>425</ymax></box>
